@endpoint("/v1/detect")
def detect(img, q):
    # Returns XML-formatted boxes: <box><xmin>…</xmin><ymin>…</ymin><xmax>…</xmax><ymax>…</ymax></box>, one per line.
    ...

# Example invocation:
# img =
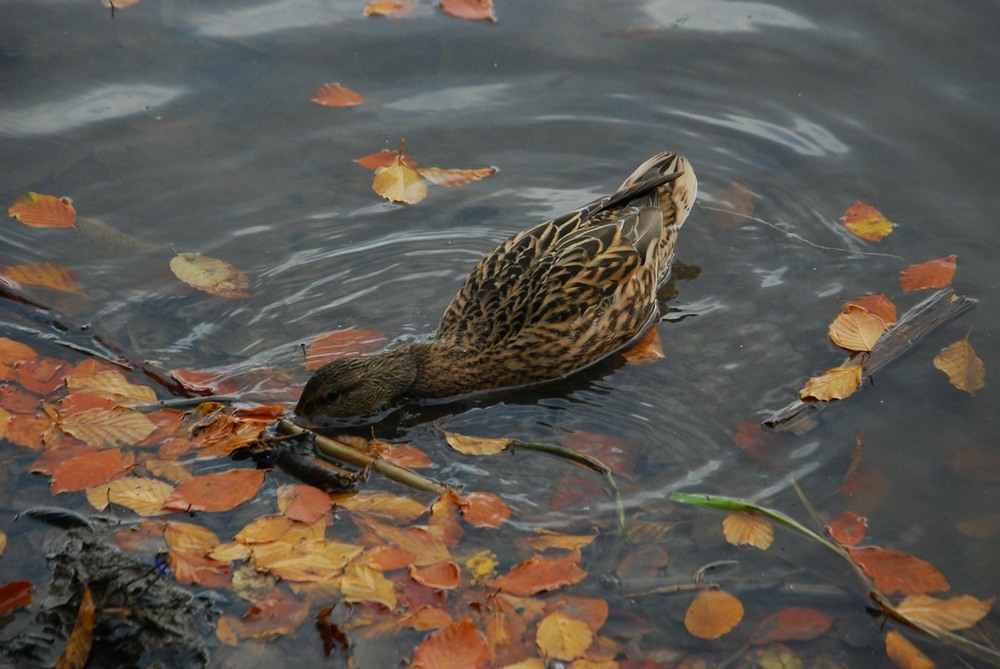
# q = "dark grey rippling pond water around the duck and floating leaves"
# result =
<box><xmin>0</xmin><ymin>0</ymin><xmax>1000</xmax><ymax>666</ymax></box>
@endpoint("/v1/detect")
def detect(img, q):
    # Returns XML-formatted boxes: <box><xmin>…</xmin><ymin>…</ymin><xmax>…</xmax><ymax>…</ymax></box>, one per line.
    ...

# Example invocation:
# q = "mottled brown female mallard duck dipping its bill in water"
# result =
<box><xmin>295</xmin><ymin>153</ymin><xmax>698</xmax><ymax>418</ymax></box>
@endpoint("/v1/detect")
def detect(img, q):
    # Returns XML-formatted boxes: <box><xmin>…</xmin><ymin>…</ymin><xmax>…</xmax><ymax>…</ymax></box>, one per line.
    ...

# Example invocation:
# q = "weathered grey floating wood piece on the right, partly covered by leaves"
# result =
<box><xmin>761</xmin><ymin>288</ymin><xmax>976</xmax><ymax>434</ymax></box>
